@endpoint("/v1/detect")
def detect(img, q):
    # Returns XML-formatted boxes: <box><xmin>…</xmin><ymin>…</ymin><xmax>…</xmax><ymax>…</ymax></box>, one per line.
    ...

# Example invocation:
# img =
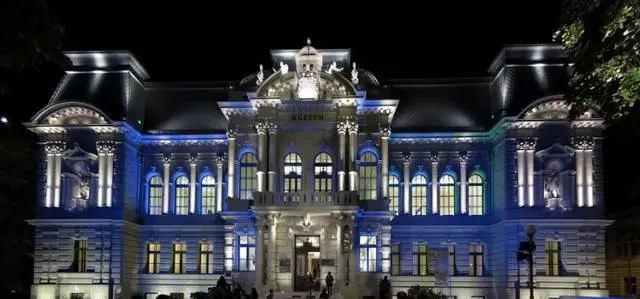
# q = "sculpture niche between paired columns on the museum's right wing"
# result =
<box><xmin>535</xmin><ymin>143</ymin><xmax>574</xmax><ymax>210</ymax></box>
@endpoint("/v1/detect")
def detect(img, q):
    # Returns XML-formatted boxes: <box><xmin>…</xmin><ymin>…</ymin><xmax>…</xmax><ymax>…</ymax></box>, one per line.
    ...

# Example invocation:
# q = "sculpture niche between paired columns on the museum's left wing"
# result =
<box><xmin>62</xmin><ymin>144</ymin><xmax>98</xmax><ymax>210</ymax></box>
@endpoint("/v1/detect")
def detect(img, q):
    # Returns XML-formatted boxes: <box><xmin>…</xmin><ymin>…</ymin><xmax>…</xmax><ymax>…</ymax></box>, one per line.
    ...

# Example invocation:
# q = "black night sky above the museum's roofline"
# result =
<box><xmin>8</xmin><ymin>0</ymin><xmax>640</xmax><ymax>214</ymax></box>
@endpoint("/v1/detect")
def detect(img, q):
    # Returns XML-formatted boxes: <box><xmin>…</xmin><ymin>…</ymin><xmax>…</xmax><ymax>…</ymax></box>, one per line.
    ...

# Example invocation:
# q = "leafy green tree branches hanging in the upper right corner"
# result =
<box><xmin>554</xmin><ymin>0</ymin><xmax>640</xmax><ymax>123</ymax></box>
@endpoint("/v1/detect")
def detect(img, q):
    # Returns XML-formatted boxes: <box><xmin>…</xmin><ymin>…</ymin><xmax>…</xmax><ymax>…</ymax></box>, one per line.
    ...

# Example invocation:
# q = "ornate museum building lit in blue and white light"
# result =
<box><xmin>26</xmin><ymin>43</ymin><xmax>611</xmax><ymax>299</ymax></box>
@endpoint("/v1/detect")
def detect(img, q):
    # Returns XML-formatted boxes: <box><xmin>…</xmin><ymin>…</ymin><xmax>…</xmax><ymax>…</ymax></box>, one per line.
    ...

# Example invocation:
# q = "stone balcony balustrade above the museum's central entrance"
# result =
<box><xmin>254</xmin><ymin>191</ymin><xmax>358</xmax><ymax>206</ymax></box>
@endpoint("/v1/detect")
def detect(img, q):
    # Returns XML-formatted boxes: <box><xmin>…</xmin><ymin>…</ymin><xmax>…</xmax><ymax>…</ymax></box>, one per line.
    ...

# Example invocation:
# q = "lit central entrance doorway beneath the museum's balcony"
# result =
<box><xmin>293</xmin><ymin>235</ymin><xmax>320</xmax><ymax>292</ymax></box>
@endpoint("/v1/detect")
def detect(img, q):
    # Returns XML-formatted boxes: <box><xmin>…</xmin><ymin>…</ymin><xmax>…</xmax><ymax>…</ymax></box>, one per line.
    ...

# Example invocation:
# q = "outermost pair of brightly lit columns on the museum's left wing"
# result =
<box><xmin>44</xmin><ymin>141</ymin><xmax>64</xmax><ymax>208</ymax></box>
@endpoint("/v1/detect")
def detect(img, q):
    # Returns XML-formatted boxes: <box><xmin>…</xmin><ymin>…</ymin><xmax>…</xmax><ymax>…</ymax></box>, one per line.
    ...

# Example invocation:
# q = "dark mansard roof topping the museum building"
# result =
<box><xmin>28</xmin><ymin>44</ymin><xmax>571</xmax><ymax>134</ymax></box>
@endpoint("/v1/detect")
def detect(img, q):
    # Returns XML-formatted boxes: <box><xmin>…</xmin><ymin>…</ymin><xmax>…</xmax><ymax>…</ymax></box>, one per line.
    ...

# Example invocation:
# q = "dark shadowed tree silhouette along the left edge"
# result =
<box><xmin>0</xmin><ymin>0</ymin><xmax>68</xmax><ymax>298</ymax></box>
